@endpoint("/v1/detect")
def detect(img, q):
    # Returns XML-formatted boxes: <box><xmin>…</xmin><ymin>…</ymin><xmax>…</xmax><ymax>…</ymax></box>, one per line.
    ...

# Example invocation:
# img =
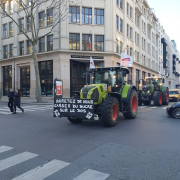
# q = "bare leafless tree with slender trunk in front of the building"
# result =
<box><xmin>0</xmin><ymin>0</ymin><xmax>79</xmax><ymax>102</ymax></box>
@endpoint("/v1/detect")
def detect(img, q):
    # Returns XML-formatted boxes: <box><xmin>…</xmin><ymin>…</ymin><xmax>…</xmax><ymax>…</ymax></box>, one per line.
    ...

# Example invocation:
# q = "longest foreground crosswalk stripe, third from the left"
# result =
<box><xmin>12</xmin><ymin>160</ymin><xmax>70</xmax><ymax>180</ymax></box>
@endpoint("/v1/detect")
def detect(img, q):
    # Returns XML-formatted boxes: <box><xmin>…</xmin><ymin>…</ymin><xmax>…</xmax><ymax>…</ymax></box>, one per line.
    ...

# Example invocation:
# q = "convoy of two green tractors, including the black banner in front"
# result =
<box><xmin>54</xmin><ymin>67</ymin><xmax>169</xmax><ymax>127</ymax></box>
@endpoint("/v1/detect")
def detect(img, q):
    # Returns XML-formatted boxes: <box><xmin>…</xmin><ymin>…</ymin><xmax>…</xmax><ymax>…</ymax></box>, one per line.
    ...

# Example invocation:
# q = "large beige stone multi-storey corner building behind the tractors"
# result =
<box><xmin>0</xmin><ymin>0</ymin><xmax>180</xmax><ymax>98</ymax></box>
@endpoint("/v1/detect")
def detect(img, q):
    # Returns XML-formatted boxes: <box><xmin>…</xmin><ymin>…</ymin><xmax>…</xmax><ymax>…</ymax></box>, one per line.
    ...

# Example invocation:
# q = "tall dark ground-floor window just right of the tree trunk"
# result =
<box><xmin>39</xmin><ymin>61</ymin><xmax>53</xmax><ymax>96</ymax></box>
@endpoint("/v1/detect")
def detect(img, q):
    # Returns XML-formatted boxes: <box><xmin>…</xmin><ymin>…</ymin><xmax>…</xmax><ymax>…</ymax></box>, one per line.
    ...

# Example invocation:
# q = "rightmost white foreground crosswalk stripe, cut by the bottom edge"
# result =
<box><xmin>74</xmin><ymin>169</ymin><xmax>109</xmax><ymax>180</ymax></box>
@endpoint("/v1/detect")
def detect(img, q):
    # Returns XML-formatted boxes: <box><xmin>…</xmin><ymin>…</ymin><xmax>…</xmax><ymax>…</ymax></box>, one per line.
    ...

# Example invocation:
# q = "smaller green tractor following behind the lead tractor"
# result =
<box><xmin>138</xmin><ymin>76</ymin><xmax>169</xmax><ymax>106</ymax></box>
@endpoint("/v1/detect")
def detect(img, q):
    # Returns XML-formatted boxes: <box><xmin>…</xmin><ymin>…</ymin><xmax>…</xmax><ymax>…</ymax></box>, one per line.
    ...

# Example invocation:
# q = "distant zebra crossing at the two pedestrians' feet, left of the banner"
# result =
<box><xmin>0</xmin><ymin>105</ymin><xmax>53</xmax><ymax>115</ymax></box>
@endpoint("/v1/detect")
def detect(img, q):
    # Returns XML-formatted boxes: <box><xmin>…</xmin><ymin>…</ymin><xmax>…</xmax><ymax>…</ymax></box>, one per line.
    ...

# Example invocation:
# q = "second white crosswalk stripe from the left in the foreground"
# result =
<box><xmin>0</xmin><ymin>152</ymin><xmax>38</xmax><ymax>171</ymax></box>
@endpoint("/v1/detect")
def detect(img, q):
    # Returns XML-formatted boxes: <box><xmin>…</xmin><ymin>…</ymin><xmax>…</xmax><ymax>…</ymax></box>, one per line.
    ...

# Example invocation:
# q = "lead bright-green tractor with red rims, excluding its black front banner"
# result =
<box><xmin>68</xmin><ymin>67</ymin><xmax>138</xmax><ymax>127</ymax></box>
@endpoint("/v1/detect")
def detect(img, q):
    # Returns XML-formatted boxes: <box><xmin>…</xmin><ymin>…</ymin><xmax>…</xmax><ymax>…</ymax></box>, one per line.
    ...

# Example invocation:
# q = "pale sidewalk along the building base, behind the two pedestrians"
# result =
<box><xmin>0</xmin><ymin>96</ymin><xmax>54</xmax><ymax>105</ymax></box>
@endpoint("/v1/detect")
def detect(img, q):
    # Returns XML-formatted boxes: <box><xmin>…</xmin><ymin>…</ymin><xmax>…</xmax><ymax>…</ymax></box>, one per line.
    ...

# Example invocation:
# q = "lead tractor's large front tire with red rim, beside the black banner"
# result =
<box><xmin>102</xmin><ymin>97</ymin><xmax>119</xmax><ymax>127</ymax></box>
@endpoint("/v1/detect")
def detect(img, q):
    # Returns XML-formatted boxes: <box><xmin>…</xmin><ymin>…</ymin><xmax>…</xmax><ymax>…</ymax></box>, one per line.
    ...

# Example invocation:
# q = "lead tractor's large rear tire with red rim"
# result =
<box><xmin>123</xmin><ymin>90</ymin><xmax>138</xmax><ymax>119</ymax></box>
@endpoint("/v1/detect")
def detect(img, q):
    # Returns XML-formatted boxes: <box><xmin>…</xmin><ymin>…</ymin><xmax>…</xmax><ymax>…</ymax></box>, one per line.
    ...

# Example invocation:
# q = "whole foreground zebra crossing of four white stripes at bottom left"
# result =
<box><xmin>0</xmin><ymin>145</ymin><xmax>110</xmax><ymax>180</ymax></box>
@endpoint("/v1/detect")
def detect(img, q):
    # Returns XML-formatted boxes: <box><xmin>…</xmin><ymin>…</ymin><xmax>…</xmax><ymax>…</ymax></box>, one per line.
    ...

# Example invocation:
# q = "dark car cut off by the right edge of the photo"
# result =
<box><xmin>166</xmin><ymin>102</ymin><xmax>180</xmax><ymax>119</ymax></box>
